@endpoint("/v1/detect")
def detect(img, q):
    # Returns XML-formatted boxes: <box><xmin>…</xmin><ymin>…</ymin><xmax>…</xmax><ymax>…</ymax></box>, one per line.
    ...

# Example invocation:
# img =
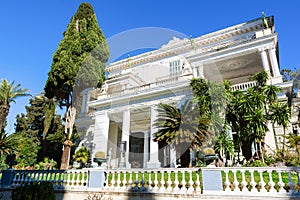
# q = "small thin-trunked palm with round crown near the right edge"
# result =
<box><xmin>269</xmin><ymin>102</ymin><xmax>291</xmax><ymax>152</ymax></box>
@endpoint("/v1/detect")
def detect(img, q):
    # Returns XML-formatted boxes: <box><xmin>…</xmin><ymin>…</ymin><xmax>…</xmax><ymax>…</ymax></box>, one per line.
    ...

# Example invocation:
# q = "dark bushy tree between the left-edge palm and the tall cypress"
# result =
<box><xmin>12</xmin><ymin>94</ymin><xmax>64</xmax><ymax>166</ymax></box>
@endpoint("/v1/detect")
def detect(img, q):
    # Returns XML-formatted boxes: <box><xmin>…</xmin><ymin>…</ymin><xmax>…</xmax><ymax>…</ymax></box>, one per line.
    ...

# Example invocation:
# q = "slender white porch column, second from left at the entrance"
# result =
<box><xmin>122</xmin><ymin>110</ymin><xmax>131</xmax><ymax>169</ymax></box>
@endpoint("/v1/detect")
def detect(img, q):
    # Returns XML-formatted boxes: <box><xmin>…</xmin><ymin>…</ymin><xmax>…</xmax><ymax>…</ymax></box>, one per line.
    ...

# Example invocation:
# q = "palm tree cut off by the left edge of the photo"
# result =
<box><xmin>0</xmin><ymin>79</ymin><xmax>30</xmax><ymax>130</ymax></box>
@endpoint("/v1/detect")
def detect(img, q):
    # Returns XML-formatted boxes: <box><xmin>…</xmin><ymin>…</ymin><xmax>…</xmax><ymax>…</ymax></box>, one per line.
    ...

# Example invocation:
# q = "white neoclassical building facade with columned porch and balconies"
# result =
<box><xmin>76</xmin><ymin>17</ymin><xmax>288</xmax><ymax>168</ymax></box>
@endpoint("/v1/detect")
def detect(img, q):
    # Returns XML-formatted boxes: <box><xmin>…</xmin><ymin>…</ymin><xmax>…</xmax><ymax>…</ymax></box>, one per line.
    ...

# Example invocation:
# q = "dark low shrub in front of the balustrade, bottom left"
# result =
<box><xmin>12</xmin><ymin>182</ymin><xmax>56</xmax><ymax>200</ymax></box>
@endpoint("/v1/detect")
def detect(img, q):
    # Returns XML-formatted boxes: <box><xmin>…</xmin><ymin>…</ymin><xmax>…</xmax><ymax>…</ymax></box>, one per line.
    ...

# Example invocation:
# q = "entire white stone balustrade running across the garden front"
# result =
<box><xmin>1</xmin><ymin>167</ymin><xmax>300</xmax><ymax>197</ymax></box>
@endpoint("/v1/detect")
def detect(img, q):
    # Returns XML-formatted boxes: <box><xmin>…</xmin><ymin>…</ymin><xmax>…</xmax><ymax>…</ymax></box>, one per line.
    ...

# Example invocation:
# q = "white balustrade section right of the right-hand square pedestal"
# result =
<box><xmin>205</xmin><ymin>167</ymin><xmax>300</xmax><ymax>195</ymax></box>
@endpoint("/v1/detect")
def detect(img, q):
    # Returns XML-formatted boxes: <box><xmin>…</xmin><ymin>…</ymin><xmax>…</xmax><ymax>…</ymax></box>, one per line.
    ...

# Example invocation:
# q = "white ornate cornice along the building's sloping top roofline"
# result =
<box><xmin>106</xmin><ymin>19</ymin><xmax>263</xmax><ymax>72</ymax></box>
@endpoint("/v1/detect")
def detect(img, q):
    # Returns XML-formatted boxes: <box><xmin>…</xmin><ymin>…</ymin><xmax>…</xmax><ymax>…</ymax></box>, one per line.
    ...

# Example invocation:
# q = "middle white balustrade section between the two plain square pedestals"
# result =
<box><xmin>103</xmin><ymin>168</ymin><xmax>201</xmax><ymax>194</ymax></box>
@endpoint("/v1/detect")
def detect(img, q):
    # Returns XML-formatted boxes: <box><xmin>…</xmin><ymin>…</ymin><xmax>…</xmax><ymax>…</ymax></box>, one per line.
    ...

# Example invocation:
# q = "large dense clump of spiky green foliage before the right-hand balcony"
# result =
<box><xmin>226</xmin><ymin>71</ymin><xmax>288</xmax><ymax>160</ymax></box>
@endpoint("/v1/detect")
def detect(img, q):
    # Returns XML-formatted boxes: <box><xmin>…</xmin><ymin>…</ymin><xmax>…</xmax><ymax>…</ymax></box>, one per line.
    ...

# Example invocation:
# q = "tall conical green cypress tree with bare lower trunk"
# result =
<box><xmin>45</xmin><ymin>3</ymin><xmax>109</xmax><ymax>169</ymax></box>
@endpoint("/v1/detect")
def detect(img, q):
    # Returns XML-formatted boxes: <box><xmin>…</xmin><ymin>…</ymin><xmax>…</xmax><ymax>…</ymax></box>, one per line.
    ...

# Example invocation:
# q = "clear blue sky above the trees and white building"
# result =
<box><xmin>0</xmin><ymin>0</ymin><xmax>300</xmax><ymax>132</ymax></box>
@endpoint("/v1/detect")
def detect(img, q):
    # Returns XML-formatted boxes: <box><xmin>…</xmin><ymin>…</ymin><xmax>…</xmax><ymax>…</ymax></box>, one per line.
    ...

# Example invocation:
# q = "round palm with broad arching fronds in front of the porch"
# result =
<box><xmin>154</xmin><ymin>101</ymin><xmax>209</xmax><ymax>167</ymax></box>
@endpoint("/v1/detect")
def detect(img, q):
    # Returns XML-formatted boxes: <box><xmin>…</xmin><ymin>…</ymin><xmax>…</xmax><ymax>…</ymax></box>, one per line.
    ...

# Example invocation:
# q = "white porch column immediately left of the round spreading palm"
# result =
<box><xmin>147</xmin><ymin>106</ymin><xmax>161</xmax><ymax>168</ymax></box>
